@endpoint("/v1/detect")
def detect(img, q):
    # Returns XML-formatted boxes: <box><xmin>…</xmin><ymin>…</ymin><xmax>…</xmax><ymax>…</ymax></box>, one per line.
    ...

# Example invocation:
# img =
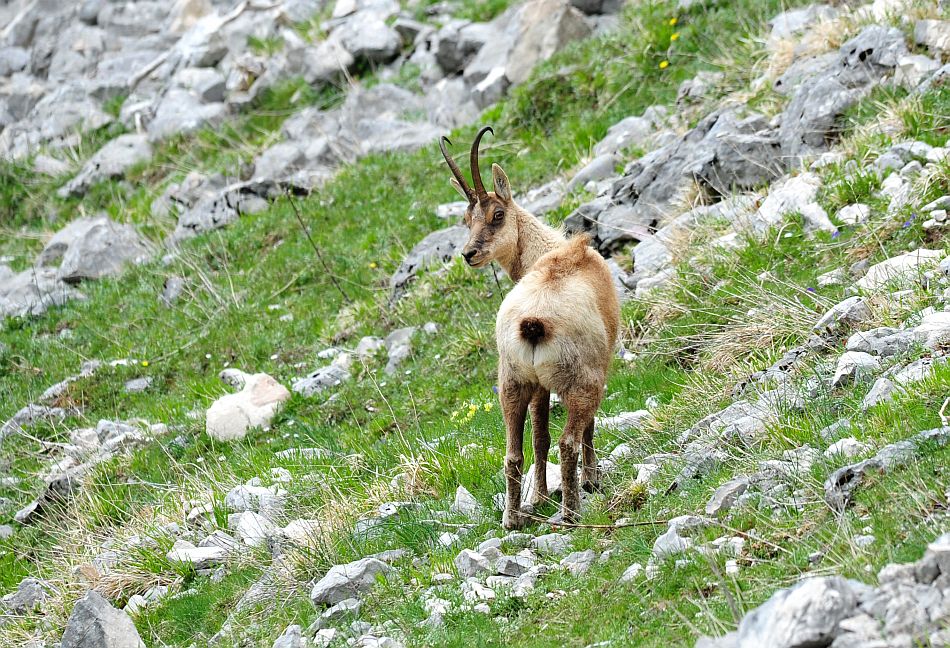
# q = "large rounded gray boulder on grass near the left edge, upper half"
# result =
<box><xmin>57</xmin><ymin>216</ymin><xmax>149</xmax><ymax>284</ymax></box>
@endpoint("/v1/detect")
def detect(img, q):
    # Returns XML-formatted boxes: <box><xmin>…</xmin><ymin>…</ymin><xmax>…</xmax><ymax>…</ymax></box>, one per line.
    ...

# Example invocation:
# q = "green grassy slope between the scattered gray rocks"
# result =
<box><xmin>0</xmin><ymin>0</ymin><xmax>950</xmax><ymax>646</ymax></box>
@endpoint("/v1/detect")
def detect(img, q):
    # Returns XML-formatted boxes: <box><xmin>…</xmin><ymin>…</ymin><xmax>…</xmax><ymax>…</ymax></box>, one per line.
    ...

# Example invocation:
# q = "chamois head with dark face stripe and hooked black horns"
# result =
<box><xmin>439</xmin><ymin>126</ymin><xmax>518</xmax><ymax>268</ymax></box>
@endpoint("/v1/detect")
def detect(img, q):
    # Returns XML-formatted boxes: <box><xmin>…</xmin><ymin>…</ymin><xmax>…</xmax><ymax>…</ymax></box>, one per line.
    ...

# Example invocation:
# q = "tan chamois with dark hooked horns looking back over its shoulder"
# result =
<box><xmin>439</xmin><ymin>126</ymin><xmax>620</xmax><ymax>529</ymax></box>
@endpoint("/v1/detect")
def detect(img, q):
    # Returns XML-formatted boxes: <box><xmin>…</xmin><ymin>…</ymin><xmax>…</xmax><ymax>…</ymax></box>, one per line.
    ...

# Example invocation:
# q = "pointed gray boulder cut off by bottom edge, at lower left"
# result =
<box><xmin>60</xmin><ymin>590</ymin><xmax>145</xmax><ymax>648</ymax></box>
